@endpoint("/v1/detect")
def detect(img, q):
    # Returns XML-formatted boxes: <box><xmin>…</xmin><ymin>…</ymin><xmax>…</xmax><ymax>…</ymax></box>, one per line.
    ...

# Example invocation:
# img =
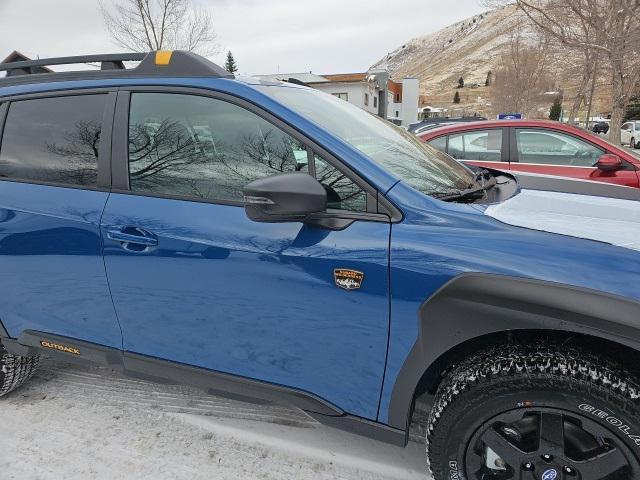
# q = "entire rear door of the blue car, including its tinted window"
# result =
<box><xmin>0</xmin><ymin>90</ymin><xmax>122</xmax><ymax>348</ymax></box>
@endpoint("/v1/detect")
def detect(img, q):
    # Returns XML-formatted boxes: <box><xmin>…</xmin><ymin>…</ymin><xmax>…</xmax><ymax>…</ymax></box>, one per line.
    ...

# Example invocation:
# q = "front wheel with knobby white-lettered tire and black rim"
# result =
<box><xmin>427</xmin><ymin>346</ymin><xmax>640</xmax><ymax>480</ymax></box>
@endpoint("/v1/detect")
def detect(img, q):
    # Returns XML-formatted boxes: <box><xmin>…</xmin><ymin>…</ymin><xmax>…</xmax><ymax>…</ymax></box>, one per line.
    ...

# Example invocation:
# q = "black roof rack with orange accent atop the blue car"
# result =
<box><xmin>0</xmin><ymin>50</ymin><xmax>233</xmax><ymax>86</ymax></box>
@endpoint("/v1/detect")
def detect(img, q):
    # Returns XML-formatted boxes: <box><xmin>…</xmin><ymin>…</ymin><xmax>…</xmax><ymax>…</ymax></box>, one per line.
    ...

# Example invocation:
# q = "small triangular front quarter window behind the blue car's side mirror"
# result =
<box><xmin>315</xmin><ymin>155</ymin><xmax>367</xmax><ymax>212</ymax></box>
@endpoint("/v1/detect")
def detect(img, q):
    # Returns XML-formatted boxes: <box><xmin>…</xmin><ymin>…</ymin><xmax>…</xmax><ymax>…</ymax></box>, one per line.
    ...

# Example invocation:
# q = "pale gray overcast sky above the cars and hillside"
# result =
<box><xmin>0</xmin><ymin>0</ymin><xmax>483</xmax><ymax>74</ymax></box>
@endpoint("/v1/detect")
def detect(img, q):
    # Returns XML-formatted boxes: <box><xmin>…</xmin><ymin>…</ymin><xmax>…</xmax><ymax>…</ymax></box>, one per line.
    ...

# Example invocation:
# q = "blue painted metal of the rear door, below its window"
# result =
<box><xmin>0</xmin><ymin>182</ymin><xmax>122</xmax><ymax>348</ymax></box>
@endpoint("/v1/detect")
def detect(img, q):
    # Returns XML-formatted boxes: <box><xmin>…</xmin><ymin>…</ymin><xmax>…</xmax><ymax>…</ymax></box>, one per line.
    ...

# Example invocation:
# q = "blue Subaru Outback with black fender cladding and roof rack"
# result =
<box><xmin>0</xmin><ymin>51</ymin><xmax>640</xmax><ymax>480</ymax></box>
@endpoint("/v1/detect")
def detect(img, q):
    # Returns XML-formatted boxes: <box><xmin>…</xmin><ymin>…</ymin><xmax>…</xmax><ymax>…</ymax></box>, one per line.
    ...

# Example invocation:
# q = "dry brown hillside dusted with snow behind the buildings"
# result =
<box><xmin>372</xmin><ymin>5</ymin><xmax>608</xmax><ymax>120</ymax></box>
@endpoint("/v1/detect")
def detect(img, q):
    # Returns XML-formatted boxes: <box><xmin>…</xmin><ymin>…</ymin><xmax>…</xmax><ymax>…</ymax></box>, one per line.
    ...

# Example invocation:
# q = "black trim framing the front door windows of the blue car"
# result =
<box><xmin>111</xmin><ymin>85</ymin><xmax>403</xmax><ymax>223</ymax></box>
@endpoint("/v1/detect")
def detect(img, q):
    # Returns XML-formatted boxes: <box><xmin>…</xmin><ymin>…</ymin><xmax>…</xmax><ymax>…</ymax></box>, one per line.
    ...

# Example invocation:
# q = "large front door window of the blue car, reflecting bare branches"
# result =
<box><xmin>129</xmin><ymin>93</ymin><xmax>308</xmax><ymax>201</ymax></box>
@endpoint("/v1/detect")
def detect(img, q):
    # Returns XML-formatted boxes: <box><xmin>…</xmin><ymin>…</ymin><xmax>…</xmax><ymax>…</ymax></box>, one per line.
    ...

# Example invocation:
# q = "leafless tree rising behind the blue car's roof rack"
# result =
<box><xmin>100</xmin><ymin>0</ymin><xmax>217</xmax><ymax>55</ymax></box>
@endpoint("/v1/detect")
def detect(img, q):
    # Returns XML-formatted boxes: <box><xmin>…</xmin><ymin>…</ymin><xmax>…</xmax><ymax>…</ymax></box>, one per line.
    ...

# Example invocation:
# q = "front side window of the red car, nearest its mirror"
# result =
<box><xmin>516</xmin><ymin>129</ymin><xmax>604</xmax><ymax>167</ymax></box>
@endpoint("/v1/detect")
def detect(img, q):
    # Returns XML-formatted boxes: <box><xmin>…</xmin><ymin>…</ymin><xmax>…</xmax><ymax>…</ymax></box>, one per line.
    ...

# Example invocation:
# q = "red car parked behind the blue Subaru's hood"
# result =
<box><xmin>418</xmin><ymin>120</ymin><xmax>640</xmax><ymax>188</ymax></box>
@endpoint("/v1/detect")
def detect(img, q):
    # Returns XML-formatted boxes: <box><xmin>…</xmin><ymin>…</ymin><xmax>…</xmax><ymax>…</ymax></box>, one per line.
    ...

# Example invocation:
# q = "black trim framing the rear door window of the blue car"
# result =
<box><xmin>0</xmin><ymin>87</ymin><xmax>117</xmax><ymax>192</ymax></box>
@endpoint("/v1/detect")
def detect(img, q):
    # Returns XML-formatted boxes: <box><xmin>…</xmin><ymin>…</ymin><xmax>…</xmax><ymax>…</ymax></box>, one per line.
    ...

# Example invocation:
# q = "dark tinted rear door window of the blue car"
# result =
<box><xmin>0</xmin><ymin>95</ymin><xmax>106</xmax><ymax>186</ymax></box>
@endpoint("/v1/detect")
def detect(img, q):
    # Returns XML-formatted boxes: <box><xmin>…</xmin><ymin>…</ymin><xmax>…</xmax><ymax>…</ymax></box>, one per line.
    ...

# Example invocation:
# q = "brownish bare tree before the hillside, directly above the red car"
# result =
<box><xmin>491</xmin><ymin>27</ymin><xmax>553</xmax><ymax>115</ymax></box>
